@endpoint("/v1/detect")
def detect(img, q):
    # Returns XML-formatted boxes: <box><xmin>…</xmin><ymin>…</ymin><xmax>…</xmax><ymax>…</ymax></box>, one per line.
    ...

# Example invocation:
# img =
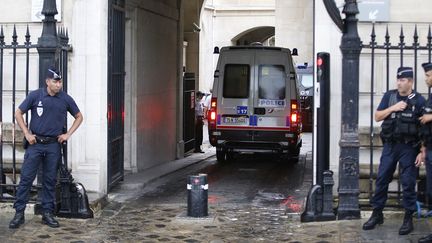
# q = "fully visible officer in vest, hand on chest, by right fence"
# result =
<box><xmin>363</xmin><ymin>67</ymin><xmax>425</xmax><ymax>235</ymax></box>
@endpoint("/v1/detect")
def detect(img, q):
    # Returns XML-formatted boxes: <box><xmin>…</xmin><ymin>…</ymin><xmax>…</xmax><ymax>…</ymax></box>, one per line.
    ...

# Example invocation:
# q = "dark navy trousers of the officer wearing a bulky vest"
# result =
<box><xmin>371</xmin><ymin>143</ymin><xmax>418</xmax><ymax>211</ymax></box>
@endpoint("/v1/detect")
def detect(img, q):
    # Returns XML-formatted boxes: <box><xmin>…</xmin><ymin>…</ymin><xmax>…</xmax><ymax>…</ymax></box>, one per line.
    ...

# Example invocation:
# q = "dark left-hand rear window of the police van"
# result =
<box><xmin>223</xmin><ymin>64</ymin><xmax>250</xmax><ymax>98</ymax></box>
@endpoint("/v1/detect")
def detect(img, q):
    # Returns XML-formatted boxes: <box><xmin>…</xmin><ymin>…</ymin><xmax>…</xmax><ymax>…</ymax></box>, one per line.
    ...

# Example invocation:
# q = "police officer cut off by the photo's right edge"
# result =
<box><xmin>416</xmin><ymin>63</ymin><xmax>432</xmax><ymax>243</ymax></box>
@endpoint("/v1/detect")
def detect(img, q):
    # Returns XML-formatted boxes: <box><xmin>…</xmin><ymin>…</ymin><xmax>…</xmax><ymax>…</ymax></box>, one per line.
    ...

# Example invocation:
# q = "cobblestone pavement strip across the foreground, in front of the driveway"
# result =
<box><xmin>0</xmin><ymin>201</ymin><xmax>430</xmax><ymax>243</ymax></box>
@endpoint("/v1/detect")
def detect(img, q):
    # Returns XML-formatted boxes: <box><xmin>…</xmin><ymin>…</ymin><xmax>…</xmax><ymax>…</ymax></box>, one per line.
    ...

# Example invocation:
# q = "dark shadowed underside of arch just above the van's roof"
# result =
<box><xmin>232</xmin><ymin>26</ymin><xmax>275</xmax><ymax>45</ymax></box>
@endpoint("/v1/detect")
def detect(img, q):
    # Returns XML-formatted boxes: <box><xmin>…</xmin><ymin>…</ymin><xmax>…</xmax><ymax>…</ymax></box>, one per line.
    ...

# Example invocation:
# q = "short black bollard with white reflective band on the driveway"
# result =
<box><xmin>187</xmin><ymin>174</ymin><xmax>208</xmax><ymax>217</ymax></box>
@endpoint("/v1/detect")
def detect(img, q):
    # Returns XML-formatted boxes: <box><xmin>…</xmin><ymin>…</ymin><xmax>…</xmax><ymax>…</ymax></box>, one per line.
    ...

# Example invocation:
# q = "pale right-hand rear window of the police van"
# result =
<box><xmin>258</xmin><ymin>65</ymin><xmax>286</xmax><ymax>100</ymax></box>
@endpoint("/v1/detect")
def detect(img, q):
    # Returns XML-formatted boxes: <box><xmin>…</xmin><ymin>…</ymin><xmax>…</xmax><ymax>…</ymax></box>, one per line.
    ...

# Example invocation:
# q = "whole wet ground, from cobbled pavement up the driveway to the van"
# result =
<box><xmin>0</xmin><ymin>134</ymin><xmax>432</xmax><ymax>243</ymax></box>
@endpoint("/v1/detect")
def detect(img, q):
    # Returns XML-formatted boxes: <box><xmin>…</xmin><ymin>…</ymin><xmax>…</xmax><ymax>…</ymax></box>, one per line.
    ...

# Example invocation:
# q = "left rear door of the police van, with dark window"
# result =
<box><xmin>217</xmin><ymin>49</ymin><xmax>254</xmax><ymax>138</ymax></box>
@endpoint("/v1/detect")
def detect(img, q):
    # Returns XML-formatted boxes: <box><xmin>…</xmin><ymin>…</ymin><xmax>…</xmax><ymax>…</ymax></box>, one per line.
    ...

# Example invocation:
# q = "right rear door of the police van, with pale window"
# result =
<box><xmin>251</xmin><ymin>49</ymin><xmax>292</xmax><ymax>133</ymax></box>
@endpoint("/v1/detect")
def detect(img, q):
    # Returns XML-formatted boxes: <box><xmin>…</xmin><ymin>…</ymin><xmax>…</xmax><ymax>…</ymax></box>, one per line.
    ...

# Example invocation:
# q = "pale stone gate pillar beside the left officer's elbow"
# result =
<box><xmin>64</xmin><ymin>0</ymin><xmax>108</xmax><ymax>193</ymax></box>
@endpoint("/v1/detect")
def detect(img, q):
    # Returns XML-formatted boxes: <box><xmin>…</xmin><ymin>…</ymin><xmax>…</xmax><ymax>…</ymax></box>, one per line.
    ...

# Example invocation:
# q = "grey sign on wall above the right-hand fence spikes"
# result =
<box><xmin>357</xmin><ymin>0</ymin><xmax>390</xmax><ymax>22</ymax></box>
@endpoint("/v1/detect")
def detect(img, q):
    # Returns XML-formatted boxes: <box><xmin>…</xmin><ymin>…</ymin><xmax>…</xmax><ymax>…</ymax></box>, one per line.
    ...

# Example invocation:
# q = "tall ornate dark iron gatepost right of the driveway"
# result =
<box><xmin>338</xmin><ymin>0</ymin><xmax>362</xmax><ymax>219</ymax></box>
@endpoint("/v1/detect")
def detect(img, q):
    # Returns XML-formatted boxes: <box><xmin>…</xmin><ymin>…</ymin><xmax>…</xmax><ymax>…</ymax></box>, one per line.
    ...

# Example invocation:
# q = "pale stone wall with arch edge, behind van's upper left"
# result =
<box><xmin>199</xmin><ymin>0</ymin><xmax>275</xmax><ymax>92</ymax></box>
